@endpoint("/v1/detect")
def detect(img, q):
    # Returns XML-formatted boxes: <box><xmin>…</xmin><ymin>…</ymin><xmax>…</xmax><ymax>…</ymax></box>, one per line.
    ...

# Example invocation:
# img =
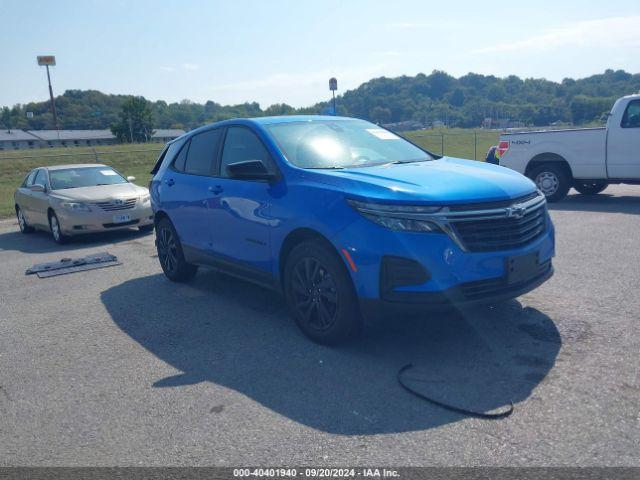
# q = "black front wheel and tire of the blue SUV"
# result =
<box><xmin>284</xmin><ymin>240</ymin><xmax>362</xmax><ymax>345</ymax></box>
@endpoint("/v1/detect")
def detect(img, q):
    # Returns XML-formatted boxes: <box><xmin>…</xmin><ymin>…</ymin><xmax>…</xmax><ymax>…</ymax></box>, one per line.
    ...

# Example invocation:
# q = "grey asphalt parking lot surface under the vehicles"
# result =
<box><xmin>0</xmin><ymin>186</ymin><xmax>640</xmax><ymax>466</ymax></box>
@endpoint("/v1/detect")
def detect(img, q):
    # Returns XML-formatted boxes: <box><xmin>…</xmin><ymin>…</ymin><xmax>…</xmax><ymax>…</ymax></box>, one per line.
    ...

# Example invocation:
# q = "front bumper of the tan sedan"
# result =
<box><xmin>56</xmin><ymin>204</ymin><xmax>153</xmax><ymax>235</ymax></box>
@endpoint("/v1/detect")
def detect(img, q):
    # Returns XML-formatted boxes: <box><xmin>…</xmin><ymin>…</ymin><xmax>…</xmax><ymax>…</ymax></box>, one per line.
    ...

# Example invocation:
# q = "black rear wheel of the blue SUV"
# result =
<box><xmin>156</xmin><ymin>218</ymin><xmax>198</xmax><ymax>282</ymax></box>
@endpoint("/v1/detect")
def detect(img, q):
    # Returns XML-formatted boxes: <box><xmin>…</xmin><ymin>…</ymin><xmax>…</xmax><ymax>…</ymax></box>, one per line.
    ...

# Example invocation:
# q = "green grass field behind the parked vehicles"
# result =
<box><xmin>0</xmin><ymin>129</ymin><xmax>499</xmax><ymax>218</ymax></box>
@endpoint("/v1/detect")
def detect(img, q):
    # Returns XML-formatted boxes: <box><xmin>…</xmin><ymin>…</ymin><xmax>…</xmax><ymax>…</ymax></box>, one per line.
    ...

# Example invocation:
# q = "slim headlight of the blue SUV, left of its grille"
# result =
<box><xmin>347</xmin><ymin>200</ymin><xmax>442</xmax><ymax>233</ymax></box>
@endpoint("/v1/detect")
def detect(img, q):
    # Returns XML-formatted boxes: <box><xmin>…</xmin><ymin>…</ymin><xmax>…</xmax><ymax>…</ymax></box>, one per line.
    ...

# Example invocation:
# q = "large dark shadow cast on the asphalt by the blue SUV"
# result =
<box><xmin>101</xmin><ymin>271</ymin><xmax>561</xmax><ymax>435</ymax></box>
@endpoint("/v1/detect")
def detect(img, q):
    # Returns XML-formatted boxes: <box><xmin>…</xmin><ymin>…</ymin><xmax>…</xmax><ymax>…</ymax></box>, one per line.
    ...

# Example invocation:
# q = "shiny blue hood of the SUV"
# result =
<box><xmin>312</xmin><ymin>157</ymin><xmax>536</xmax><ymax>205</ymax></box>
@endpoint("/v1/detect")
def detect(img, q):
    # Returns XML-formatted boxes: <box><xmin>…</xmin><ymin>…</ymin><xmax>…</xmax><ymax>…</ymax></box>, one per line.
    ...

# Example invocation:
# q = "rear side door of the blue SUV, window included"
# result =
<box><xmin>158</xmin><ymin>129</ymin><xmax>221</xmax><ymax>256</ymax></box>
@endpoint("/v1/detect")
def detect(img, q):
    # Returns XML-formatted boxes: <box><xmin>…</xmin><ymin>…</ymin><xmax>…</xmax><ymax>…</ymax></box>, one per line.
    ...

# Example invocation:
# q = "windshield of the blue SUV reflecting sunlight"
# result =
<box><xmin>265</xmin><ymin>120</ymin><xmax>433</xmax><ymax>168</ymax></box>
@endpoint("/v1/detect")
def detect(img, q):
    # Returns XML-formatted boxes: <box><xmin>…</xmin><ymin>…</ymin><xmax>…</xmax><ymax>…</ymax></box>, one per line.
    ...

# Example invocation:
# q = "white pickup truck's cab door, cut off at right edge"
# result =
<box><xmin>607</xmin><ymin>100</ymin><xmax>640</xmax><ymax>179</ymax></box>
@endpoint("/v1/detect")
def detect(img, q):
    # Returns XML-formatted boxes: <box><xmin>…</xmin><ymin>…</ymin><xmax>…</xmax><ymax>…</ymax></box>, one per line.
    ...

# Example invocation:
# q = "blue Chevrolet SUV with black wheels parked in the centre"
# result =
<box><xmin>150</xmin><ymin>116</ymin><xmax>554</xmax><ymax>343</ymax></box>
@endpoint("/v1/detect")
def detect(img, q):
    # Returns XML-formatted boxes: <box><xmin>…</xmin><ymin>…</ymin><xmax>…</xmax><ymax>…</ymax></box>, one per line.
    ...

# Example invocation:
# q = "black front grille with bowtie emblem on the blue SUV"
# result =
<box><xmin>449</xmin><ymin>193</ymin><xmax>547</xmax><ymax>252</ymax></box>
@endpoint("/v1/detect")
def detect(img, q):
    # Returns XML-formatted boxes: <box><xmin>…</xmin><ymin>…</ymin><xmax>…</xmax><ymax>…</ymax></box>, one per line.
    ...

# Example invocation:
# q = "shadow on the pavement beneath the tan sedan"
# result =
<box><xmin>0</xmin><ymin>224</ymin><xmax>153</xmax><ymax>253</ymax></box>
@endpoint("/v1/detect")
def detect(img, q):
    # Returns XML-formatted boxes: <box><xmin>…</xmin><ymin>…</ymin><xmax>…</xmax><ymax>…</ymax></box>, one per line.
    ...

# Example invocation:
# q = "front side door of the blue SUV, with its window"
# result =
<box><xmin>208</xmin><ymin>125</ymin><xmax>276</xmax><ymax>272</ymax></box>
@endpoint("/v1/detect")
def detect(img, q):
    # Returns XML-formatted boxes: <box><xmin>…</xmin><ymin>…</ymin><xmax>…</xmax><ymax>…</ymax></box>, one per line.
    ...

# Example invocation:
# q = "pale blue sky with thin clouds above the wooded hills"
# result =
<box><xmin>0</xmin><ymin>0</ymin><xmax>640</xmax><ymax>108</ymax></box>
